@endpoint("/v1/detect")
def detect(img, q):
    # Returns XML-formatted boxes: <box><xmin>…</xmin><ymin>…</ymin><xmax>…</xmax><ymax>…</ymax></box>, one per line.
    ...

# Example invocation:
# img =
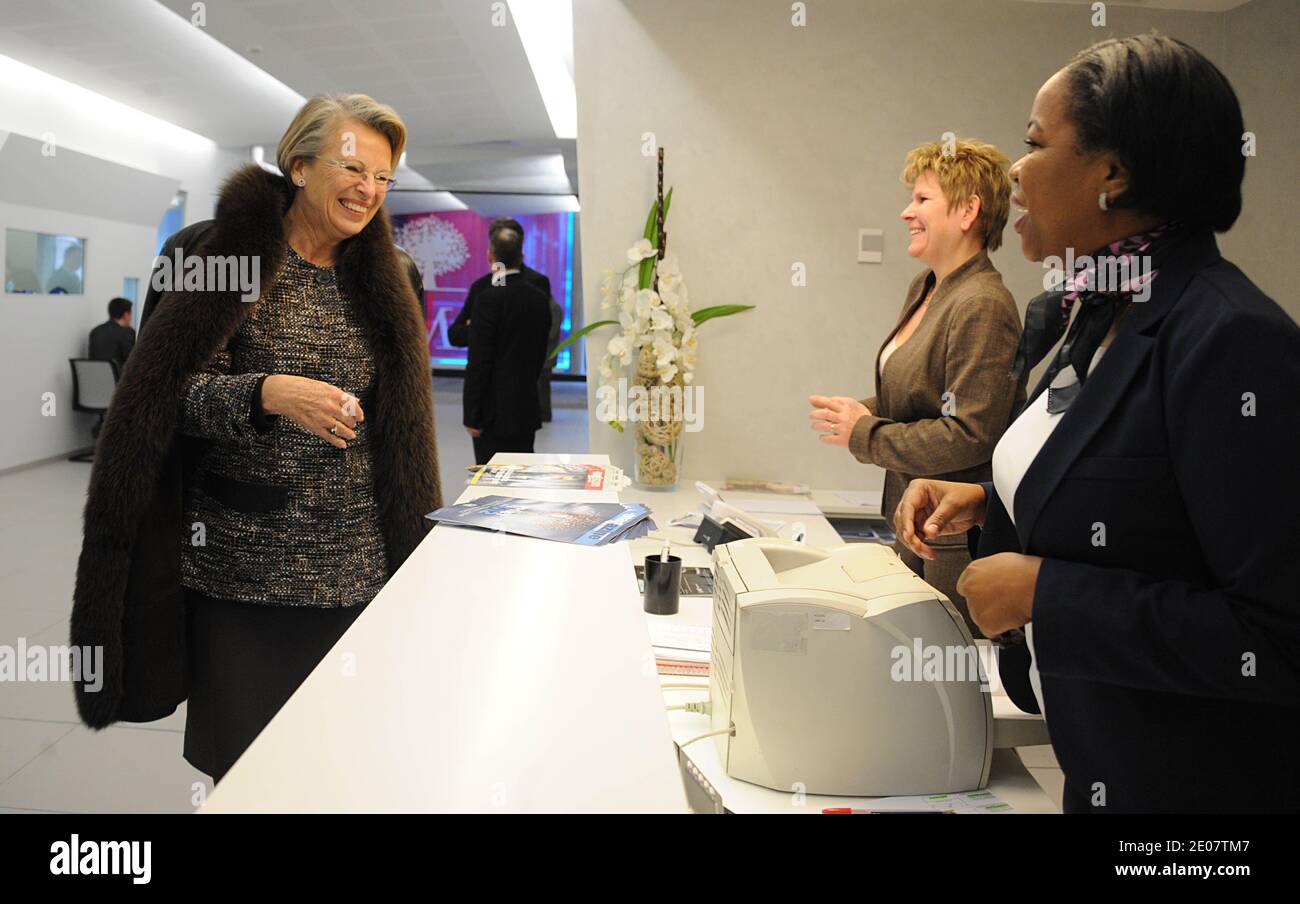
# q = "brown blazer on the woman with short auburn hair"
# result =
<box><xmin>849</xmin><ymin>251</ymin><xmax>1024</xmax><ymax>528</ymax></box>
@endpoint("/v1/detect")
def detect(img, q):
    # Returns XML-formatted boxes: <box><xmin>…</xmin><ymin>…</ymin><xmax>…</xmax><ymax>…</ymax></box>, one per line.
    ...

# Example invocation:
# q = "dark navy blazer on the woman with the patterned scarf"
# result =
<box><xmin>978</xmin><ymin>230</ymin><xmax>1300</xmax><ymax>813</ymax></box>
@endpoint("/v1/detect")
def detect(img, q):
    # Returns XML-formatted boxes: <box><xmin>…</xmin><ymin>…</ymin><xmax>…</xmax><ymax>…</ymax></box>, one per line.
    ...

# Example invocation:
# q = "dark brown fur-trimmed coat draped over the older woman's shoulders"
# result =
<box><xmin>72</xmin><ymin>165</ymin><xmax>442</xmax><ymax>728</ymax></box>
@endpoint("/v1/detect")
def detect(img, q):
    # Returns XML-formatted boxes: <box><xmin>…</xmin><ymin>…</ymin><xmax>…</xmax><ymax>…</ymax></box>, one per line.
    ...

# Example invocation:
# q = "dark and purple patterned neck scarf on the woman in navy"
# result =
<box><xmin>1011</xmin><ymin>222</ymin><xmax>1179</xmax><ymax>414</ymax></box>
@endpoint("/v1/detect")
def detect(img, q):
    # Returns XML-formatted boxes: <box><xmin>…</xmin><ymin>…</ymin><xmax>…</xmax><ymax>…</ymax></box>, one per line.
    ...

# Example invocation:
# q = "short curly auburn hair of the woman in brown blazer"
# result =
<box><xmin>900</xmin><ymin>138</ymin><xmax>1011</xmax><ymax>251</ymax></box>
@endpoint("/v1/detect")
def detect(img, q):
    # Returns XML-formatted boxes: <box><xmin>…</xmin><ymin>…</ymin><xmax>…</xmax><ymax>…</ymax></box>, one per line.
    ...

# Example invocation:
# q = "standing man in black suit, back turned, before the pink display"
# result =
<box><xmin>464</xmin><ymin>222</ymin><xmax>551</xmax><ymax>464</ymax></box>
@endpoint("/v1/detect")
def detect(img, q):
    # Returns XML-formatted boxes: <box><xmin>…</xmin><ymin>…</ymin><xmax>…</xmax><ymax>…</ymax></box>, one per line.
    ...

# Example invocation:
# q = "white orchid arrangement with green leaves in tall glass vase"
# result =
<box><xmin>551</xmin><ymin>148</ymin><xmax>754</xmax><ymax>489</ymax></box>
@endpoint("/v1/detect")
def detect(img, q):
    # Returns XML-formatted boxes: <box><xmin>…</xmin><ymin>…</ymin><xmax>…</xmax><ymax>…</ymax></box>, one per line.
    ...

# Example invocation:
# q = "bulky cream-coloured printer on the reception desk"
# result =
<box><xmin>709</xmin><ymin>537</ymin><xmax>993</xmax><ymax>797</ymax></box>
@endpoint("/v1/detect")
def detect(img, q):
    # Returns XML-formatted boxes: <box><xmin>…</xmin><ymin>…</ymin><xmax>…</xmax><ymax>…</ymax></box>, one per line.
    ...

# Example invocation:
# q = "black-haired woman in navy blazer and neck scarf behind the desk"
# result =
<box><xmin>896</xmin><ymin>35</ymin><xmax>1300</xmax><ymax>813</ymax></box>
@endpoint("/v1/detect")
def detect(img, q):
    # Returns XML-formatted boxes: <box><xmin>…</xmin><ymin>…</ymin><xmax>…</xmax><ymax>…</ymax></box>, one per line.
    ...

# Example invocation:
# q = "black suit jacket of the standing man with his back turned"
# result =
<box><xmin>464</xmin><ymin>273</ymin><xmax>551</xmax><ymax>436</ymax></box>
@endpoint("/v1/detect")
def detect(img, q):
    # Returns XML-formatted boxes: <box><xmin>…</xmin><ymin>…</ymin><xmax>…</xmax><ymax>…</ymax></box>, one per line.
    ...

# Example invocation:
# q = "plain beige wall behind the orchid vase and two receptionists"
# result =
<box><xmin>573</xmin><ymin>0</ymin><xmax>1295</xmax><ymax>488</ymax></box>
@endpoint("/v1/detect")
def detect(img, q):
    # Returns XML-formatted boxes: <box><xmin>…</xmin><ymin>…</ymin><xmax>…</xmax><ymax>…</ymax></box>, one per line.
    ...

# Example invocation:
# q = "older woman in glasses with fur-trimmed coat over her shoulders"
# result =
<box><xmin>72</xmin><ymin>95</ymin><xmax>441</xmax><ymax>779</ymax></box>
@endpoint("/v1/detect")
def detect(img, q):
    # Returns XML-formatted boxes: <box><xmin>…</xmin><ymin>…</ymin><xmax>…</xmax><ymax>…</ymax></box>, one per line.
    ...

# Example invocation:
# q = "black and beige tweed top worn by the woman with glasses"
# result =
<box><xmin>181</xmin><ymin>247</ymin><xmax>387</xmax><ymax>607</ymax></box>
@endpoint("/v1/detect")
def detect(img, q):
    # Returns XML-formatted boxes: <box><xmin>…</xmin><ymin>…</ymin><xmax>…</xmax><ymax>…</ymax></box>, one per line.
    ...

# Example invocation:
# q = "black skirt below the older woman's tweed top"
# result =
<box><xmin>185</xmin><ymin>591</ymin><xmax>365</xmax><ymax>782</ymax></box>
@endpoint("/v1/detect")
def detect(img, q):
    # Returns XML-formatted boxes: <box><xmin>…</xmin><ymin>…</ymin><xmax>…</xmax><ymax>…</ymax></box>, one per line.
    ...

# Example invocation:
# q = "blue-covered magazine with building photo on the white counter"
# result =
<box><xmin>425</xmin><ymin>496</ymin><xmax>650</xmax><ymax>546</ymax></box>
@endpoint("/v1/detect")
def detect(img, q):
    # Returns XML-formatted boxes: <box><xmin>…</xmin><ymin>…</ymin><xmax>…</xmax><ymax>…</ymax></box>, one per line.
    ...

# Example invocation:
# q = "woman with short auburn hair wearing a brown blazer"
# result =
<box><xmin>809</xmin><ymin>139</ymin><xmax>1024</xmax><ymax>637</ymax></box>
